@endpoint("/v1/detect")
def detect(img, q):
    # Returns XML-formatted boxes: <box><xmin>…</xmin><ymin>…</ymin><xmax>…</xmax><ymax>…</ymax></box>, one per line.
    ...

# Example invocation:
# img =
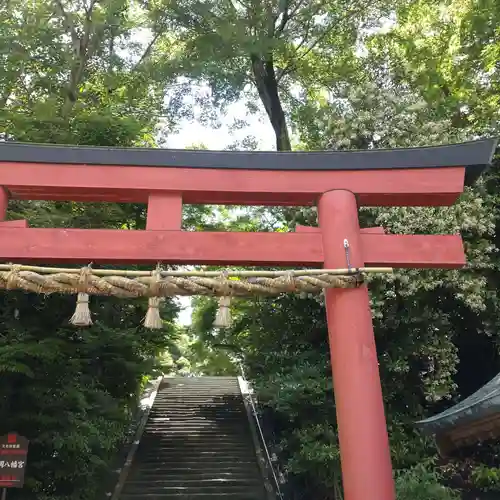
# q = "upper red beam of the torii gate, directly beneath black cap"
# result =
<box><xmin>0</xmin><ymin>162</ymin><xmax>465</xmax><ymax>206</ymax></box>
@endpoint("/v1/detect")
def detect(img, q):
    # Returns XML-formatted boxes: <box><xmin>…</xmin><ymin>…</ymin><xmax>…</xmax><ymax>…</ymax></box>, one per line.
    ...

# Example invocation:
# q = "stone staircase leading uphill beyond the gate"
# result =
<box><xmin>118</xmin><ymin>377</ymin><xmax>268</xmax><ymax>500</ymax></box>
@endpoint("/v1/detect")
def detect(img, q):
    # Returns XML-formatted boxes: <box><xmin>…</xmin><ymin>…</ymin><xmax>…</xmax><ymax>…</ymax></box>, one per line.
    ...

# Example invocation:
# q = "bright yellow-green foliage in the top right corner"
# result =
<box><xmin>369</xmin><ymin>0</ymin><xmax>500</xmax><ymax>134</ymax></box>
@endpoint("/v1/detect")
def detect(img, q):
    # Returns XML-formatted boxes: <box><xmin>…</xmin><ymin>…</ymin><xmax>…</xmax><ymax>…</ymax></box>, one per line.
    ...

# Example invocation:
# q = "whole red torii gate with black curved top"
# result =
<box><xmin>0</xmin><ymin>140</ymin><xmax>495</xmax><ymax>500</ymax></box>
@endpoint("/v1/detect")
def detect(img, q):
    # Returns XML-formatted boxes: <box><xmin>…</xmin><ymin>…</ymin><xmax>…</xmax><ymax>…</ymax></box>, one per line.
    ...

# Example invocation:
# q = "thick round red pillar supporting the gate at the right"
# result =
<box><xmin>318</xmin><ymin>190</ymin><xmax>395</xmax><ymax>500</ymax></box>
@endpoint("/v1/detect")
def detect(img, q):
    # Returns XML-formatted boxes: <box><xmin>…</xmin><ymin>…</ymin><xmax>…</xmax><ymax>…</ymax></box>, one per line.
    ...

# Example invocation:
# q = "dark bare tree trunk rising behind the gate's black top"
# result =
<box><xmin>250</xmin><ymin>55</ymin><xmax>292</xmax><ymax>151</ymax></box>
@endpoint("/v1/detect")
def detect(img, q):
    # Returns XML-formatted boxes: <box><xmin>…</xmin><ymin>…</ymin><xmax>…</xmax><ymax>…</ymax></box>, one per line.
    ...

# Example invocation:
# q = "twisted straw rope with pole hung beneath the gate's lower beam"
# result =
<box><xmin>0</xmin><ymin>264</ymin><xmax>392</xmax><ymax>298</ymax></box>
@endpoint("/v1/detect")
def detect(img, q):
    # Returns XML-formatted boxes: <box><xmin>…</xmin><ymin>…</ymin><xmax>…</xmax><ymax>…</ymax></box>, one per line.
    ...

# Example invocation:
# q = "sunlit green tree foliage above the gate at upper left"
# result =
<box><xmin>0</xmin><ymin>0</ymin><xmax>178</xmax><ymax>145</ymax></box>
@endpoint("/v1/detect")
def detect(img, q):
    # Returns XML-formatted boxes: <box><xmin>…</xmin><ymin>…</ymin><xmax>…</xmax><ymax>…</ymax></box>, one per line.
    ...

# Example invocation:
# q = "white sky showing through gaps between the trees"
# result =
<box><xmin>166</xmin><ymin>96</ymin><xmax>275</xmax><ymax>325</ymax></box>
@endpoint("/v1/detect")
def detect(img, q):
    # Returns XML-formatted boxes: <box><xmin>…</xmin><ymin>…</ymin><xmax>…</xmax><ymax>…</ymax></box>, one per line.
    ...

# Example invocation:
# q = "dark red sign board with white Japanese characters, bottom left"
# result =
<box><xmin>0</xmin><ymin>432</ymin><xmax>29</xmax><ymax>488</ymax></box>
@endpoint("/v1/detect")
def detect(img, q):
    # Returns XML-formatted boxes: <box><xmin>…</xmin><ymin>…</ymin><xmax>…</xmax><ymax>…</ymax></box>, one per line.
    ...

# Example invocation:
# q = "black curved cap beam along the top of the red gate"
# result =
<box><xmin>0</xmin><ymin>139</ymin><xmax>497</xmax><ymax>184</ymax></box>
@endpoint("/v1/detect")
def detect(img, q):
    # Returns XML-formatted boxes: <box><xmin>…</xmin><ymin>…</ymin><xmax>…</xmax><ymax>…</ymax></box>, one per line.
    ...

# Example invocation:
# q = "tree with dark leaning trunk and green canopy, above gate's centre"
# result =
<box><xmin>141</xmin><ymin>0</ymin><xmax>383</xmax><ymax>151</ymax></box>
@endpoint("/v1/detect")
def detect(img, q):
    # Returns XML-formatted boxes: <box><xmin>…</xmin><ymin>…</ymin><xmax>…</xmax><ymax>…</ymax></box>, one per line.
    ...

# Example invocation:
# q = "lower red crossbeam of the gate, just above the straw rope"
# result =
<box><xmin>0</xmin><ymin>227</ymin><xmax>465</xmax><ymax>268</ymax></box>
